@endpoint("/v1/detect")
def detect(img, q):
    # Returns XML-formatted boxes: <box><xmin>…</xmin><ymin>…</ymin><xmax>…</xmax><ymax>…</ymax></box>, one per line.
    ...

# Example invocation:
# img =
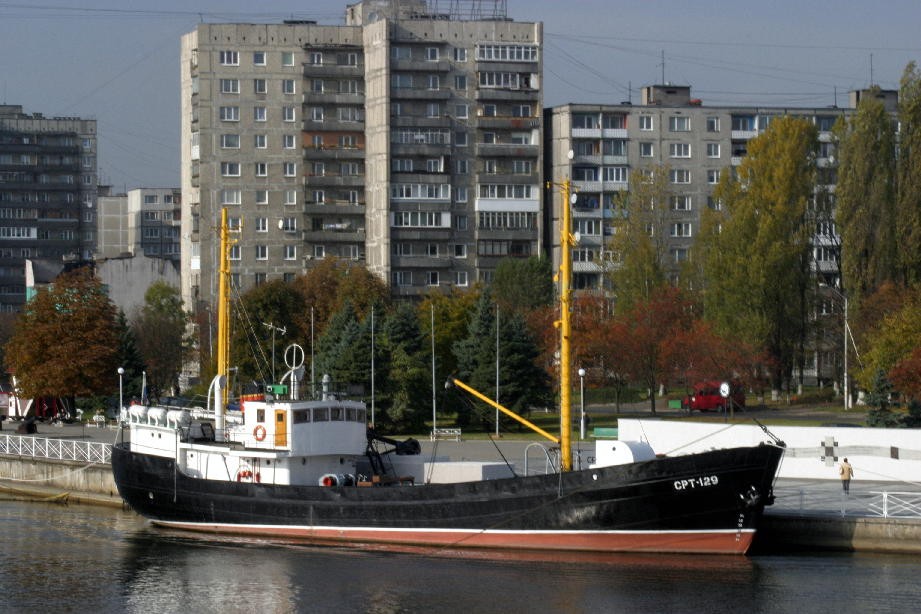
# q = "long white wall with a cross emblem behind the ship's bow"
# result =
<box><xmin>618</xmin><ymin>419</ymin><xmax>921</xmax><ymax>482</ymax></box>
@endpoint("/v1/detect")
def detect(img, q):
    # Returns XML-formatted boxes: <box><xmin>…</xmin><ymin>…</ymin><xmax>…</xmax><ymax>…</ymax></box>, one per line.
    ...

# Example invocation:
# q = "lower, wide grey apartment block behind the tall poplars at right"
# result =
<box><xmin>545</xmin><ymin>85</ymin><xmax>898</xmax><ymax>388</ymax></box>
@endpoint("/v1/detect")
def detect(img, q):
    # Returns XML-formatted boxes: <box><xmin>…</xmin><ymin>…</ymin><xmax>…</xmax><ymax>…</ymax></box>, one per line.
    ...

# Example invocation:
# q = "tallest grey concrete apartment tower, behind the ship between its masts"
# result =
<box><xmin>181</xmin><ymin>0</ymin><xmax>543</xmax><ymax>305</ymax></box>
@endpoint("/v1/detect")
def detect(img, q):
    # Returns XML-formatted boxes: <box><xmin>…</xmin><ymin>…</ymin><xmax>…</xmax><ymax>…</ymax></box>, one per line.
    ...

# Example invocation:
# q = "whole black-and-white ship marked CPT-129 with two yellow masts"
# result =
<box><xmin>112</xmin><ymin>182</ymin><xmax>784</xmax><ymax>554</ymax></box>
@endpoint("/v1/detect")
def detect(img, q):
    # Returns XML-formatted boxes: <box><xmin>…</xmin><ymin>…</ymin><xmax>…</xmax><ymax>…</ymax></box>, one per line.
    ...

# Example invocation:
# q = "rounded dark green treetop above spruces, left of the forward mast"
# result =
<box><xmin>491</xmin><ymin>256</ymin><xmax>556</xmax><ymax>314</ymax></box>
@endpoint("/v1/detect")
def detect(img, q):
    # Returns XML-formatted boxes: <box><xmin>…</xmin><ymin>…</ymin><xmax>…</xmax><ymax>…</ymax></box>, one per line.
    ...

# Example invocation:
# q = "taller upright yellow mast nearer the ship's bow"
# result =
<box><xmin>559</xmin><ymin>179</ymin><xmax>575</xmax><ymax>471</ymax></box>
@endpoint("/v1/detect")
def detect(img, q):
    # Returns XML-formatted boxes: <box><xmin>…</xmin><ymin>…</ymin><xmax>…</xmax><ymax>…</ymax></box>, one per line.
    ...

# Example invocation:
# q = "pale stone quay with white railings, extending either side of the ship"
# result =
<box><xmin>0</xmin><ymin>422</ymin><xmax>921</xmax><ymax>554</ymax></box>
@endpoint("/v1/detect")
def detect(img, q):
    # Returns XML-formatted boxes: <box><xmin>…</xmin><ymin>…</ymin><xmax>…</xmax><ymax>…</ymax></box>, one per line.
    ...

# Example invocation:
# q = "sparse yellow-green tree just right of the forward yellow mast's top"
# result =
<box><xmin>610</xmin><ymin>166</ymin><xmax>671</xmax><ymax>312</ymax></box>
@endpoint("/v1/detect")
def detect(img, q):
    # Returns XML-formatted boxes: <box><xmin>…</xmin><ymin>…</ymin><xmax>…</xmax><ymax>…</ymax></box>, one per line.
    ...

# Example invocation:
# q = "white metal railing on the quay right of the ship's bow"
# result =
<box><xmin>773</xmin><ymin>480</ymin><xmax>921</xmax><ymax>519</ymax></box>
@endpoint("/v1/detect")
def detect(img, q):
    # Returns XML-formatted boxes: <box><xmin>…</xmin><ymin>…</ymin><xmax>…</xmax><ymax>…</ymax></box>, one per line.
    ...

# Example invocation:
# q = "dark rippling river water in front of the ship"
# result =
<box><xmin>0</xmin><ymin>500</ymin><xmax>921</xmax><ymax>614</ymax></box>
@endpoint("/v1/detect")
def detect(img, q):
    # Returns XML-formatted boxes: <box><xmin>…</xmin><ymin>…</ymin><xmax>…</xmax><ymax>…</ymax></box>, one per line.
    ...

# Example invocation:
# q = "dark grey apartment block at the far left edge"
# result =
<box><xmin>0</xmin><ymin>105</ymin><xmax>97</xmax><ymax>311</ymax></box>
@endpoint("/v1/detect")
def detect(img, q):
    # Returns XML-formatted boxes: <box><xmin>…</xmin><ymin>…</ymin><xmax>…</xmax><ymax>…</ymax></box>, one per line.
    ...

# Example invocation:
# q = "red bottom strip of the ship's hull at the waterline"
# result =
<box><xmin>153</xmin><ymin>520</ymin><xmax>755</xmax><ymax>554</ymax></box>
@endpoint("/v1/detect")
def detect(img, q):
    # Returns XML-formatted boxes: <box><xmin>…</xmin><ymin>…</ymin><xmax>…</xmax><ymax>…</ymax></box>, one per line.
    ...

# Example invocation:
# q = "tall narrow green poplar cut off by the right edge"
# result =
<box><xmin>895</xmin><ymin>62</ymin><xmax>921</xmax><ymax>285</ymax></box>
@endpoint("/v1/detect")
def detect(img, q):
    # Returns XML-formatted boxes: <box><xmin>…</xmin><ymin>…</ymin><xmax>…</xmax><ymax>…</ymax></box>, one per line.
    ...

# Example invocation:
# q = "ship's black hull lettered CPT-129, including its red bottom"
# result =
<box><xmin>112</xmin><ymin>444</ymin><xmax>783</xmax><ymax>553</ymax></box>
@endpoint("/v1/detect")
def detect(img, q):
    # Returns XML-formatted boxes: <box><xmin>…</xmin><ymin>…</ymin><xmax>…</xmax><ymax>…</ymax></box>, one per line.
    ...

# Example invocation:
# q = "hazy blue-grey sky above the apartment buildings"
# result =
<box><xmin>0</xmin><ymin>0</ymin><xmax>921</xmax><ymax>191</ymax></box>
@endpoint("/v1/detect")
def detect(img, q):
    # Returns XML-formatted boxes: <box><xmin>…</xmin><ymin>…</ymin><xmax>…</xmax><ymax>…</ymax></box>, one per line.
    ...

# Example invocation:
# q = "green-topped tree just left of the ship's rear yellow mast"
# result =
<box><xmin>132</xmin><ymin>281</ymin><xmax>192</xmax><ymax>399</ymax></box>
